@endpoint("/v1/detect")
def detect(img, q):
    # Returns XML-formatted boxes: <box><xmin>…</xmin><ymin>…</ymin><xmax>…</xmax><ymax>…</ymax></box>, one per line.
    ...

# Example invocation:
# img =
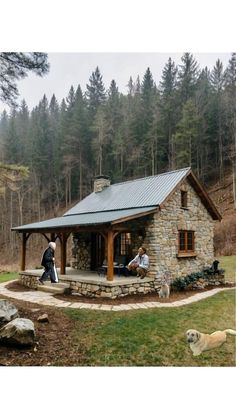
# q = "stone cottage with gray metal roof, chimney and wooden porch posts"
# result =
<box><xmin>13</xmin><ymin>167</ymin><xmax>221</xmax><ymax>288</ymax></box>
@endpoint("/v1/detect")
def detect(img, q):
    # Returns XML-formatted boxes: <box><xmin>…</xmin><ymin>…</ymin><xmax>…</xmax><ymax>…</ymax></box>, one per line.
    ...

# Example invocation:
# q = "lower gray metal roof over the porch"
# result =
<box><xmin>12</xmin><ymin>206</ymin><xmax>157</xmax><ymax>231</ymax></box>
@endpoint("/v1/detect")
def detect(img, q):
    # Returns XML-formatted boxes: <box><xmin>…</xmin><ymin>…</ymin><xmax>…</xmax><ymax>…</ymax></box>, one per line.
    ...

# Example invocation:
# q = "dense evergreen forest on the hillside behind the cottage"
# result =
<box><xmin>0</xmin><ymin>53</ymin><xmax>236</xmax><ymax>257</ymax></box>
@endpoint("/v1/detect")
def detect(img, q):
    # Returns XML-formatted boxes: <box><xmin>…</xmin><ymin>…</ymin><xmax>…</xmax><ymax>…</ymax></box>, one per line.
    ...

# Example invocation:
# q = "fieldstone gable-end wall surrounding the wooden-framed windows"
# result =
<box><xmin>145</xmin><ymin>180</ymin><xmax>218</xmax><ymax>280</ymax></box>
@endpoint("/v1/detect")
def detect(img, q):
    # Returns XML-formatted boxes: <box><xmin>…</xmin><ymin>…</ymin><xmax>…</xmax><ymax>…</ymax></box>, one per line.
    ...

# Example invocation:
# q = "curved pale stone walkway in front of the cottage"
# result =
<box><xmin>0</xmin><ymin>280</ymin><xmax>236</xmax><ymax>311</ymax></box>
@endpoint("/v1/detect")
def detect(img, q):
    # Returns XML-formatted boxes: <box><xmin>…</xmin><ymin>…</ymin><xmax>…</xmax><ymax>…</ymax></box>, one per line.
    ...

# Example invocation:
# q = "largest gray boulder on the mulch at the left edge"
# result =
<box><xmin>0</xmin><ymin>318</ymin><xmax>35</xmax><ymax>346</ymax></box>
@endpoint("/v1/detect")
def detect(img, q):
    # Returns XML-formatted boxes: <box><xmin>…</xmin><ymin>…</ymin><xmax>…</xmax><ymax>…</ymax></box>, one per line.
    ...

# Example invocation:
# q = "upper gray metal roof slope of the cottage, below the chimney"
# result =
<box><xmin>64</xmin><ymin>167</ymin><xmax>191</xmax><ymax>216</ymax></box>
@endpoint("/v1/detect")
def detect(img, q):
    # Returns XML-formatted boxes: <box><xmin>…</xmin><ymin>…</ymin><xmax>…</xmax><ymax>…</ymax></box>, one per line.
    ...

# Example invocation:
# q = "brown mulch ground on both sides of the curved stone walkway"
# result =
<box><xmin>0</xmin><ymin>282</ymin><xmax>234</xmax><ymax>366</ymax></box>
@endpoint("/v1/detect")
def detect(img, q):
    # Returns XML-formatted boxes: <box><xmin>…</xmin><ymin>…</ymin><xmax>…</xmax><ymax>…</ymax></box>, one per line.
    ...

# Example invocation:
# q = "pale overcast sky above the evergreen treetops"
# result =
<box><xmin>0</xmin><ymin>52</ymin><xmax>231</xmax><ymax>112</ymax></box>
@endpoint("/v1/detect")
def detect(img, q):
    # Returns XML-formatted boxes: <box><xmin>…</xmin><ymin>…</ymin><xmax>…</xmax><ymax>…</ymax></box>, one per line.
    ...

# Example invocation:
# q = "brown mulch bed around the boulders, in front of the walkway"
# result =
<box><xmin>0</xmin><ymin>295</ymin><xmax>85</xmax><ymax>366</ymax></box>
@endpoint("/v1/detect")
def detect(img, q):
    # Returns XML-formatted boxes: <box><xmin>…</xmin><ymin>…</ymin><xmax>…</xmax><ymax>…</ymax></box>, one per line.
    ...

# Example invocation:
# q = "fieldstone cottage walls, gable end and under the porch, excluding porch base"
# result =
<box><xmin>68</xmin><ymin>180</ymin><xmax>218</xmax><ymax>283</ymax></box>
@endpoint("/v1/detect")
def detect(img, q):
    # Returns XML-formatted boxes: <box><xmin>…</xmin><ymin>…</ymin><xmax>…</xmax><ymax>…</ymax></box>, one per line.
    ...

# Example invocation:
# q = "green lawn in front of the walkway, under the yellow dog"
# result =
<box><xmin>65</xmin><ymin>290</ymin><xmax>236</xmax><ymax>367</ymax></box>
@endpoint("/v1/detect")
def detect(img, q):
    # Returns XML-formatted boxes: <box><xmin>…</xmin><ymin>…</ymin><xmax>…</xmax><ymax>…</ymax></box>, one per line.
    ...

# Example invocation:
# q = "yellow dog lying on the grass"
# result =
<box><xmin>186</xmin><ymin>329</ymin><xmax>236</xmax><ymax>356</ymax></box>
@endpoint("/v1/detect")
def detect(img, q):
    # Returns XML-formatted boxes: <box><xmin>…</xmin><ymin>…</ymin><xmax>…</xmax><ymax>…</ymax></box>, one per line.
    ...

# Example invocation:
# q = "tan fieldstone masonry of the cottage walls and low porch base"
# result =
<box><xmin>21</xmin><ymin>180</ymin><xmax>219</xmax><ymax>298</ymax></box>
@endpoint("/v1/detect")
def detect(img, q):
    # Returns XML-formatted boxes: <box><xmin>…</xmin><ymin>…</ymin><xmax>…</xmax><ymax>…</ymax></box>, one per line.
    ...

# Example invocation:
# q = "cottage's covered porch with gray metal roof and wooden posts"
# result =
<box><xmin>12</xmin><ymin>207</ymin><xmax>157</xmax><ymax>282</ymax></box>
